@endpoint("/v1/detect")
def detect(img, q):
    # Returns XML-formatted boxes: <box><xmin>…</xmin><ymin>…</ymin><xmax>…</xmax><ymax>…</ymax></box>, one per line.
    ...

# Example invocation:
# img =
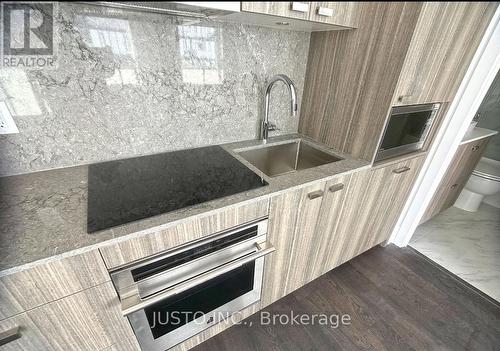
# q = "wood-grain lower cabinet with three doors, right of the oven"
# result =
<box><xmin>262</xmin><ymin>156</ymin><xmax>424</xmax><ymax>307</ymax></box>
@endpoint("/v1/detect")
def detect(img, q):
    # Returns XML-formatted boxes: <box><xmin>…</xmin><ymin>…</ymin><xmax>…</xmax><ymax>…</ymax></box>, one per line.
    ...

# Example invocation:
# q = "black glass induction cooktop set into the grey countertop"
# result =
<box><xmin>87</xmin><ymin>146</ymin><xmax>267</xmax><ymax>233</ymax></box>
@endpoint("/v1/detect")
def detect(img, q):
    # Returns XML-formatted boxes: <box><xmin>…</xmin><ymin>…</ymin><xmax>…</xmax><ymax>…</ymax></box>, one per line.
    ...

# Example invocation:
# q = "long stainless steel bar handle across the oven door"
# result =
<box><xmin>121</xmin><ymin>242</ymin><xmax>275</xmax><ymax>316</ymax></box>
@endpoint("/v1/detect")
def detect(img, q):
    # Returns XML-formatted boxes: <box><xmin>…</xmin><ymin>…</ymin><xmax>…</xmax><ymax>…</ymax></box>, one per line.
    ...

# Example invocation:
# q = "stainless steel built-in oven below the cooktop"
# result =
<box><xmin>110</xmin><ymin>219</ymin><xmax>274</xmax><ymax>351</ymax></box>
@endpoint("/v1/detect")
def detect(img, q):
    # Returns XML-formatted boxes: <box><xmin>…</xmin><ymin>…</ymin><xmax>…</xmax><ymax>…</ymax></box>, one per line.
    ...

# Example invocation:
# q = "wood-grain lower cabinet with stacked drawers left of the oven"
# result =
<box><xmin>0</xmin><ymin>249</ymin><xmax>133</xmax><ymax>351</ymax></box>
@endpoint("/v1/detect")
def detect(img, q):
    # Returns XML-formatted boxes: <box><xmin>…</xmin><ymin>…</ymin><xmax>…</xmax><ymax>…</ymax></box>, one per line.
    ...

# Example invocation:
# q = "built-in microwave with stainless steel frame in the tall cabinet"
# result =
<box><xmin>375</xmin><ymin>104</ymin><xmax>440</xmax><ymax>161</ymax></box>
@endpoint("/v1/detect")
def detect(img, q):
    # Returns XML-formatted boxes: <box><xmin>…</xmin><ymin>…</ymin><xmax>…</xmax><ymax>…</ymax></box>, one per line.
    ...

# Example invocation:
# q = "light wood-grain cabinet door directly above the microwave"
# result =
<box><xmin>393</xmin><ymin>2</ymin><xmax>498</xmax><ymax>105</ymax></box>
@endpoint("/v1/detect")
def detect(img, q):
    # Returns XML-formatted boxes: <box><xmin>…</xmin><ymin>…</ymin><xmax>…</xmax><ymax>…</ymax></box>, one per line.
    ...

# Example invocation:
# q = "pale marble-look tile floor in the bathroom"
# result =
<box><xmin>410</xmin><ymin>203</ymin><xmax>500</xmax><ymax>301</ymax></box>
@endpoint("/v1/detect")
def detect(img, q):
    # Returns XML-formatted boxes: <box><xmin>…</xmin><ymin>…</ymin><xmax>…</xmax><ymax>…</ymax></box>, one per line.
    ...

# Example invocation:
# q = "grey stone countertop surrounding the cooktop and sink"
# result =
<box><xmin>0</xmin><ymin>134</ymin><xmax>370</xmax><ymax>275</ymax></box>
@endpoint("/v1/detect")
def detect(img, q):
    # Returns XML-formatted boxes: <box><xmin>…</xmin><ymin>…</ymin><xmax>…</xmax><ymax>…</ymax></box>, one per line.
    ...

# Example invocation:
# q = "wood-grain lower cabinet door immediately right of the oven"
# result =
<box><xmin>261</xmin><ymin>182</ymin><xmax>325</xmax><ymax>307</ymax></box>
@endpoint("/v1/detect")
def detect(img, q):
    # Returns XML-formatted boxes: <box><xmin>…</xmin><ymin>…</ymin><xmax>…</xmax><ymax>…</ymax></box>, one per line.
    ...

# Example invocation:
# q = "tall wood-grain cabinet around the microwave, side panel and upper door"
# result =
<box><xmin>299</xmin><ymin>2</ymin><xmax>498</xmax><ymax>161</ymax></box>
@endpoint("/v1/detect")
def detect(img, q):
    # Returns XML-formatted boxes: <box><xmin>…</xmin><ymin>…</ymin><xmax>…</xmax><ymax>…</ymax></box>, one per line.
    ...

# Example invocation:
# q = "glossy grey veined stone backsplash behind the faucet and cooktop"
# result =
<box><xmin>0</xmin><ymin>3</ymin><xmax>310</xmax><ymax>176</ymax></box>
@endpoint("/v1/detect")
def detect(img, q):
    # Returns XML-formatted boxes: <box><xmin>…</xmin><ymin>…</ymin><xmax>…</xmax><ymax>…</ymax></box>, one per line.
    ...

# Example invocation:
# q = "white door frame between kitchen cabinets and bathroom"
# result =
<box><xmin>388</xmin><ymin>6</ymin><xmax>500</xmax><ymax>247</ymax></box>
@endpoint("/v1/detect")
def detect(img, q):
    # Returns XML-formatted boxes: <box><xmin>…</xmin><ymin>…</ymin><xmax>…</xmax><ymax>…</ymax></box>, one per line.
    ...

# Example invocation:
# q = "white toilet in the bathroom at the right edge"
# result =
<box><xmin>454</xmin><ymin>157</ymin><xmax>500</xmax><ymax>212</ymax></box>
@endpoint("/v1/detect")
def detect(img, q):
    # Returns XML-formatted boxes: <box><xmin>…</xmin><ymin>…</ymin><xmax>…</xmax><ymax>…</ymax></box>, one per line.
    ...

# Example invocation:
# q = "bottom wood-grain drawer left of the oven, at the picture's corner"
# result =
<box><xmin>0</xmin><ymin>282</ymin><xmax>134</xmax><ymax>351</ymax></box>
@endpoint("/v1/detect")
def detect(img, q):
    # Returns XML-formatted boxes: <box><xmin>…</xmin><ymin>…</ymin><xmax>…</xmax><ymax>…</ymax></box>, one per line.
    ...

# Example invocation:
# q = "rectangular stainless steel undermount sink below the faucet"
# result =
<box><xmin>237</xmin><ymin>139</ymin><xmax>342</xmax><ymax>177</ymax></box>
